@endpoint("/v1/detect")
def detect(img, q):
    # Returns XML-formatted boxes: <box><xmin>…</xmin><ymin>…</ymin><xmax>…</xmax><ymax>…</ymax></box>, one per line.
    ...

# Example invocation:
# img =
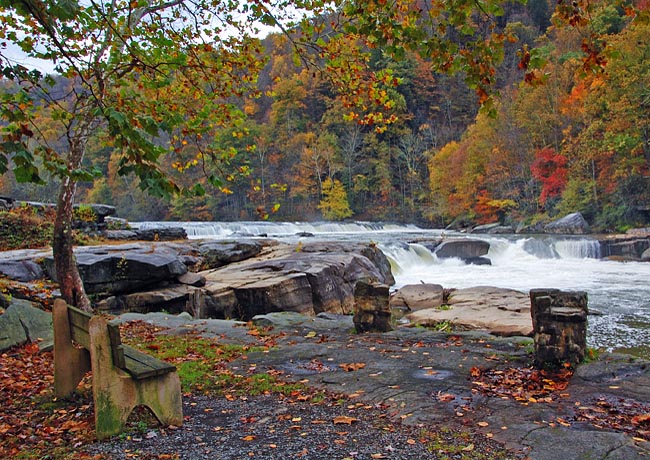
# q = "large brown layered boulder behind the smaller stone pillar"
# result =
<box><xmin>201</xmin><ymin>243</ymin><xmax>392</xmax><ymax>320</ymax></box>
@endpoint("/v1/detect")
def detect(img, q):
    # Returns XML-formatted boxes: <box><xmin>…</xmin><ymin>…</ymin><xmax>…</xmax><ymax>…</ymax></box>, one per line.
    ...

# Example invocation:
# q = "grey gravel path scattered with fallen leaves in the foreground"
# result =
<box><xmin>86</xmin><ymin>395</ymin><xmax>521</xmax><ymax>460</ymax></box>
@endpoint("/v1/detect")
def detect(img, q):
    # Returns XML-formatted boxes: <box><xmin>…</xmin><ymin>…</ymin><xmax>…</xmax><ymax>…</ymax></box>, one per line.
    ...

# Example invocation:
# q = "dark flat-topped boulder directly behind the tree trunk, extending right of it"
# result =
<box><xmin>45</xmin><ymin>244</ymin><xmax>187</xmax><ymax>294</ymax></box>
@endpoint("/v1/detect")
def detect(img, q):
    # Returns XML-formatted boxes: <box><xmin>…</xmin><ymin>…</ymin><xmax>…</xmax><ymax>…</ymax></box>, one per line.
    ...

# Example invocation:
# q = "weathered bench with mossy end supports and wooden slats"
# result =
<box><xmin>52</xmin><ymin>299</ymin><xmax>183</xmax><ymax>439</ymax></box>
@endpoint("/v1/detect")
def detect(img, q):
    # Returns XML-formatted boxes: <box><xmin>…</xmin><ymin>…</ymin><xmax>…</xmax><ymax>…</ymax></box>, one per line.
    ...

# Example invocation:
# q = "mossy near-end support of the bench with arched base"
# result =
<box><xmin>89</xmin><ymin>316</ymin><xmax>183</xmax><ymax>439</ymax></box>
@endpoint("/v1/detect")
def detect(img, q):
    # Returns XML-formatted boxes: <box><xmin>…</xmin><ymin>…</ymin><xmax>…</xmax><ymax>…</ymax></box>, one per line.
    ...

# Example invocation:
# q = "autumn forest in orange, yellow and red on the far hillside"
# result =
<box><xmin>0</xmin><ymin>0</ymin><xmax>650</xmax><ymax>231</ymax></box>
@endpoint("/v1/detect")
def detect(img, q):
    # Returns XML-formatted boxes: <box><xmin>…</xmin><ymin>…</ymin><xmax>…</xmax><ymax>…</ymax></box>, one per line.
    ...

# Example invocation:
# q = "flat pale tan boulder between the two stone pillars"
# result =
<box><xmin>407</xmin><ymin>286</ymin><xmax>533</xmax><ymax>336</ymax></box>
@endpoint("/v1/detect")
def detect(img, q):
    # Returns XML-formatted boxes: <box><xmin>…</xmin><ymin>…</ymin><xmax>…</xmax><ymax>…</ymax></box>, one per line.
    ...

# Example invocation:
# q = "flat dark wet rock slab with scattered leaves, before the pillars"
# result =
<box><xmin>243</xmin><ymin>325</ymin><xmax>650</xmax><ymax>460</ymax></box>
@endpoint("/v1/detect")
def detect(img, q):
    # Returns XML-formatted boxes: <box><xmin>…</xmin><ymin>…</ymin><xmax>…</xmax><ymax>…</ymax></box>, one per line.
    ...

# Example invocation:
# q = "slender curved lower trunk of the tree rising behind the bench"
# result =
<box><xmin>52</xmin><ymin>136</ymin><xmax>92</xmax><ymax>312</ymax></box>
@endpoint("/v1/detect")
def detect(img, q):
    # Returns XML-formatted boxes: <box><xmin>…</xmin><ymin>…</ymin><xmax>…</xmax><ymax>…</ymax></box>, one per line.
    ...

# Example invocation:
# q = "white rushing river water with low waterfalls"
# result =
<box><xmin>134</xmin><ymin>222</ymin><xmax>650</xmax><ymax>358</ymax></box>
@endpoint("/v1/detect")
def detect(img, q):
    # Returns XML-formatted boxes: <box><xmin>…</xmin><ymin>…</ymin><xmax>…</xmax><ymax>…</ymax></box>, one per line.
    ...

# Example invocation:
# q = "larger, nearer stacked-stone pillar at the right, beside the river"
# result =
<box><xmin>530</xmin><ymin>289</ymin><xmax>588</xmax><ymax>368</ymax></box>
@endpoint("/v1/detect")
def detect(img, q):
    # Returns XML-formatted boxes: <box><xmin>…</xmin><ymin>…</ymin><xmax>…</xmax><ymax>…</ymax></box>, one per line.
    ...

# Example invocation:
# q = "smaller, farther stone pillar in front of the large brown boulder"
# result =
<box><xmin>353</xmin><ymin>281</ymin><xmax>393</xmax><ymax>332</ymax></box>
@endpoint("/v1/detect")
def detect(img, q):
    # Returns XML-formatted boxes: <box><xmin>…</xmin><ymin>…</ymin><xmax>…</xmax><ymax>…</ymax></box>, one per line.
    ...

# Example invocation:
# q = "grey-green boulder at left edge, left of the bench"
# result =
<box><xmin>0</xmin><ymin>299</ymin><xmax>53</xmax><ymax>351</ymax></box>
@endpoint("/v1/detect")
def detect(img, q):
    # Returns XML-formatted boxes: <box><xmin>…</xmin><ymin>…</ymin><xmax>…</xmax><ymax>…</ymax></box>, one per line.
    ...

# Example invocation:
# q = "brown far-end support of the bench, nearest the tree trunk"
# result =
<box><xmin>52</xmin><ymin>299</ymin><xmax>90</xmax><ymax>398</ymax></box>
